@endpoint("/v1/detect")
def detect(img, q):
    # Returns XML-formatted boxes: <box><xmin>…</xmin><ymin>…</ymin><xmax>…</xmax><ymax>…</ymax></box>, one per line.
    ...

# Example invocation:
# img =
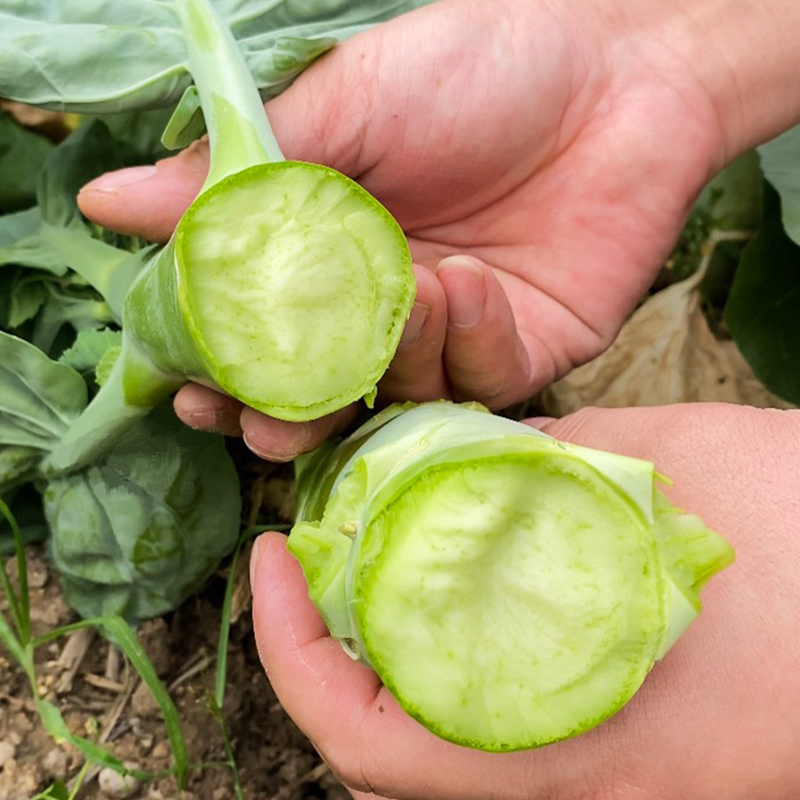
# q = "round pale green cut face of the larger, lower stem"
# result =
<box><xmin>350</xmin><ymin>454</ymin><xmax>666</xmax><ymax>750</ymax></box>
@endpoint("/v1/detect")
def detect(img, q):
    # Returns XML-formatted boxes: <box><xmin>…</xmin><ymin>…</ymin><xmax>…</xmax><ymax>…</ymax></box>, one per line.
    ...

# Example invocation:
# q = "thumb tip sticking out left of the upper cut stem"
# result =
<box><xmin>78</xmin><ymin>140</ymin><xmax>208</xmax><ymax>242</ymax></box>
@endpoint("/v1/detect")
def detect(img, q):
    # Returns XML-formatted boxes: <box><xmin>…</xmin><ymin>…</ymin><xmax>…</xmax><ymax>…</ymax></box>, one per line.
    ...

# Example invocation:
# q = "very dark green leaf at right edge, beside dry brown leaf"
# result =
<box><xmin>725</xmin><ymin>184</ymin><xmax>800</xmax><ymax>405</ymax></box>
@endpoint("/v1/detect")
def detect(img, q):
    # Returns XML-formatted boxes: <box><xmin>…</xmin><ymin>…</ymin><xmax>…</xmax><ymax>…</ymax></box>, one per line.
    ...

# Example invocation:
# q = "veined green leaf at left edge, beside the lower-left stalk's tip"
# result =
<box><xmin>0</xmin><ymin>332</ymin><xmax>87</xmax><ymax>450</ymax></box>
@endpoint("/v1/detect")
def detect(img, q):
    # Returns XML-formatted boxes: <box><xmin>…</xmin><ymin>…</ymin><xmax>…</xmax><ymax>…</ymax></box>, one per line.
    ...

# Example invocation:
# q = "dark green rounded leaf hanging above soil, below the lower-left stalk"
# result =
<box><xmin>45</xmin><ymin>403</ymin><xmax>240</xmax><ymax>622</ymax></box>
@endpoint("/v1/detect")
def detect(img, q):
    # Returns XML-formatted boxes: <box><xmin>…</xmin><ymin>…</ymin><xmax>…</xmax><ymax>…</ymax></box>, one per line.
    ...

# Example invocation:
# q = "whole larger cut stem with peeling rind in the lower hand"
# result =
<box><xmin>289</xmin><ymin>403</ymin><xmax>733</xmax><ymax>751</ymax></box>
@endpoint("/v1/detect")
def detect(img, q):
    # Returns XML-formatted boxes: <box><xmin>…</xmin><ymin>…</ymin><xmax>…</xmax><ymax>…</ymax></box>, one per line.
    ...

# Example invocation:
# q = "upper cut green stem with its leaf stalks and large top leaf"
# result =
<box><xmin>0</xmin><ymin>0</ymin><xmax>432</xmax><ymax>473</ymax></box>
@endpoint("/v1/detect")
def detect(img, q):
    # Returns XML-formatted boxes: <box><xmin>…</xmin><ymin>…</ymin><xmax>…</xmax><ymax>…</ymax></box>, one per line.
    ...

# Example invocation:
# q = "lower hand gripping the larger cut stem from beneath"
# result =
<box><xmin>251</xmin><ymin>404</ymin><xmax>800</xmax><ymax>800</ymax></box>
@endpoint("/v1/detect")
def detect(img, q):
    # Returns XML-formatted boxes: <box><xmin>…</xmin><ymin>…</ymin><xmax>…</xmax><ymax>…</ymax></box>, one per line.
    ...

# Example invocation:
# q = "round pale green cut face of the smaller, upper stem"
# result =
<box><xmin>178</xmin><ymin>162</ymin><xmax>414</xmax><ymax>419</ymax></box>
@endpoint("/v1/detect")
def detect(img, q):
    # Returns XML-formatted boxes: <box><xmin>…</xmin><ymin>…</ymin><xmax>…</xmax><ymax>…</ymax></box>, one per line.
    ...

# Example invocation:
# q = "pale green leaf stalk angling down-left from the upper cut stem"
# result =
<box><xmin>42</xmin><ymin>334</ymin><xmax>185</xmax><ymax>477</ymax></box>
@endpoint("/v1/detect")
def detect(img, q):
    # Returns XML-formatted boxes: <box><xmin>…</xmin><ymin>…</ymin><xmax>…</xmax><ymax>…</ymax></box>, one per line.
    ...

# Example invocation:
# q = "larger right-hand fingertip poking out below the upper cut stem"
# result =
<box><xmin>239</xmin><ymin>403</ymin><xmax>358</xmax><ymax>461</ymax></box>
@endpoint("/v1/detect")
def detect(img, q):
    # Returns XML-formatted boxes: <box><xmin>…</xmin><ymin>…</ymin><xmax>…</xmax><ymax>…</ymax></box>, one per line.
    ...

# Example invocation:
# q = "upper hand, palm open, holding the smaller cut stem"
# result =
<box><xmin>80</xmin><ymin>0</ymin><xmax>800</xmax><ymax>460</ymax></box>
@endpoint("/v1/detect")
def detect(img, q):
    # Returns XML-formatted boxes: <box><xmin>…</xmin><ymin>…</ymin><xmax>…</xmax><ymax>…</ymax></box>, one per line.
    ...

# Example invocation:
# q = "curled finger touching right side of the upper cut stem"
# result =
<box><xmin>380</xmin><ymin>265</ymin><xmax>449</xmax><ymax>402</ymax></box>
